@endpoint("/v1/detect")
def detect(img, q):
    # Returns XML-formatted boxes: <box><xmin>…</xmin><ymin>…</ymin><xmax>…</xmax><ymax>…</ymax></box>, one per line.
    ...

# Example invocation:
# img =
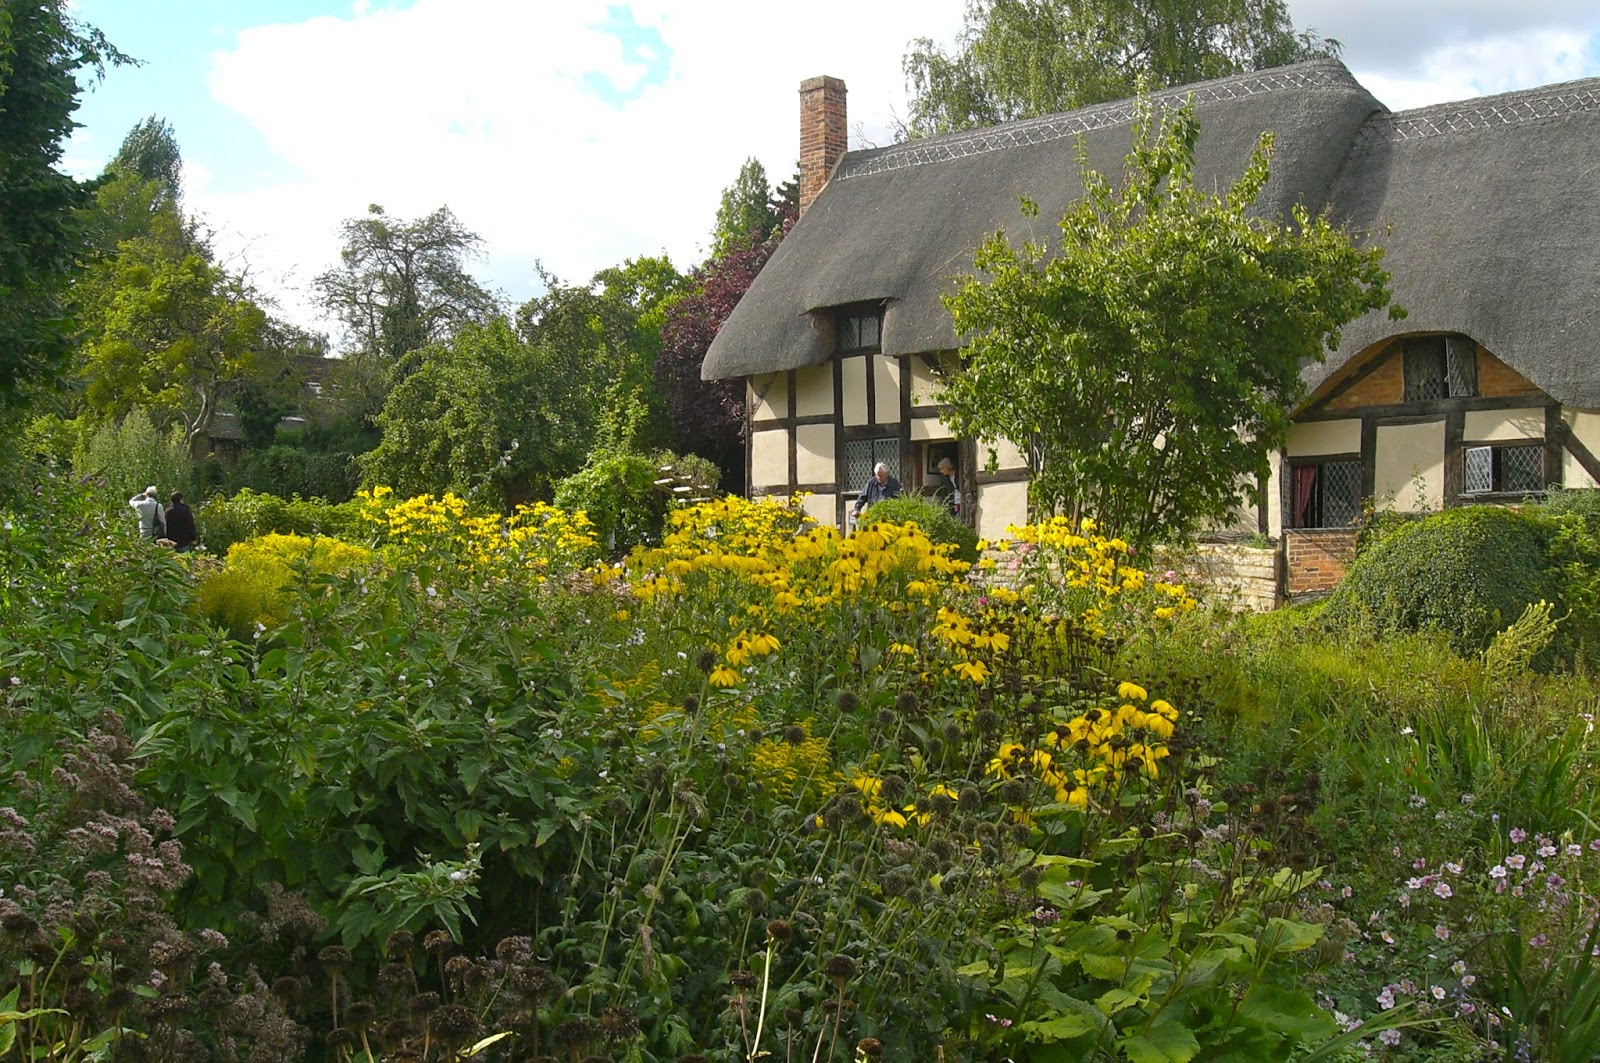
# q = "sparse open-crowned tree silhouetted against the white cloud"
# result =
<box><xmin>314</xmin><ymin>203</ymin><xmax>498</xmax><ymax>367</ymax></box>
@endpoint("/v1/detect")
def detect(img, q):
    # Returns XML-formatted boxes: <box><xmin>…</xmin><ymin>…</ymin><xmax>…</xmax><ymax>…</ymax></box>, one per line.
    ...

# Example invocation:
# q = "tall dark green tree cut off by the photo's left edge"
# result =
<box><xmin>0</xmin><ymin>0</ymin><xmax>123</xmax><ymax>410</ymax></box>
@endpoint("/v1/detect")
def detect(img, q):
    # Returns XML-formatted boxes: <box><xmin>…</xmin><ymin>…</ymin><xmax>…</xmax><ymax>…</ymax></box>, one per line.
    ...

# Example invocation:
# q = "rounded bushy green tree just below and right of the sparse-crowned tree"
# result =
<box><xmin>360</xmin><ymin>317</ymin><xmax>594</xmax><ymax>507</ymax></box>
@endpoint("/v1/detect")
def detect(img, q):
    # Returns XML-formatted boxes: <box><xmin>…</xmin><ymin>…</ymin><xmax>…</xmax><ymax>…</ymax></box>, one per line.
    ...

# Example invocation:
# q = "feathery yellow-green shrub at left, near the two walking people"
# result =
<box><xmin>197</xmin><ymin>535</ymin><xmax>371</xmax><ymax>640</ymax></box>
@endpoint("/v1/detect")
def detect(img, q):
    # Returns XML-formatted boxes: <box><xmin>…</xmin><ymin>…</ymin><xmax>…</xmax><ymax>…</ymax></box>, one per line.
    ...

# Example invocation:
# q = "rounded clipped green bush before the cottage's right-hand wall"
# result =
<box><xmin>1326</xmin><ymin>506</ymin><xmax>1562</xmax><ymax>664</ymax></box>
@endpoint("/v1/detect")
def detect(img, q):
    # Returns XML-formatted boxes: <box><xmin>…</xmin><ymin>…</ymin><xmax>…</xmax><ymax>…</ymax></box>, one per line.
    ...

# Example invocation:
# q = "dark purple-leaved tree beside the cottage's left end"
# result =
<box><xmin>656</xmin><ymin>222</ymin><xmax>794</xmax><ymax>483</ymax></box>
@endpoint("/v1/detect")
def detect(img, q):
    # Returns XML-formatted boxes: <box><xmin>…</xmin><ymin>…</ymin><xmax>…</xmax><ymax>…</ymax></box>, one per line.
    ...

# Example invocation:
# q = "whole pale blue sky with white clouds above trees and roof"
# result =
<box><xmin>64</xmin><ymin>0</ymin><xmax>1600</xmax><ymax>340</ymax></box>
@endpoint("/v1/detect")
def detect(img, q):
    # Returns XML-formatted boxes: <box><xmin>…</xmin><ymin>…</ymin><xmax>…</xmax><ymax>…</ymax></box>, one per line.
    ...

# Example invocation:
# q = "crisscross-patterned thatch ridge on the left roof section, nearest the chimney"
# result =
<box><xmin>834</xmin><ymin>62</ymin><xmax>1350</xmax><ymax>181</ymax></box>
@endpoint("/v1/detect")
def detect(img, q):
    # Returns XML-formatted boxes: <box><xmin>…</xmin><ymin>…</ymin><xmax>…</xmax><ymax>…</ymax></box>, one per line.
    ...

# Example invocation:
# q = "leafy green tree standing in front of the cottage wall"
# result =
<box><xmin>942</xmin><ymin>102</ymin><xmax>1402</xmax><ymax>543</ymax></box>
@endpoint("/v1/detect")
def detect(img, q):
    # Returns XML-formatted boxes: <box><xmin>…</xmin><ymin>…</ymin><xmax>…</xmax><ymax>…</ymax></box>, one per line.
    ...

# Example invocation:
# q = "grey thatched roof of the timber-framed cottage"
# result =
<box><xmin>702</xmin><ymin>59</ymin><xmax>1600</xmax><ymax>405</ymax></box>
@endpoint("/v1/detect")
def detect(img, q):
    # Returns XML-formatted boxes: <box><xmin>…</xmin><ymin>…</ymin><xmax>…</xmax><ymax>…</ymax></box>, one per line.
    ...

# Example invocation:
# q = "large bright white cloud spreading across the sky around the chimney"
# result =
<box><xmin>190</xmin><ymin>0</ymin><xmax>960</xmax><ymax>336</ymax></box>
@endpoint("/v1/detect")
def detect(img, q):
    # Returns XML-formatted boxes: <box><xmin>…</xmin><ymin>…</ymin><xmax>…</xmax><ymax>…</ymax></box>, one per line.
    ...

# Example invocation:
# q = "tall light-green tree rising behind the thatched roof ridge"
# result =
<box><xmin>901</xmin><ymin>0</ymin><xmax>1339</xmax><ymax>136</ymax></box>
